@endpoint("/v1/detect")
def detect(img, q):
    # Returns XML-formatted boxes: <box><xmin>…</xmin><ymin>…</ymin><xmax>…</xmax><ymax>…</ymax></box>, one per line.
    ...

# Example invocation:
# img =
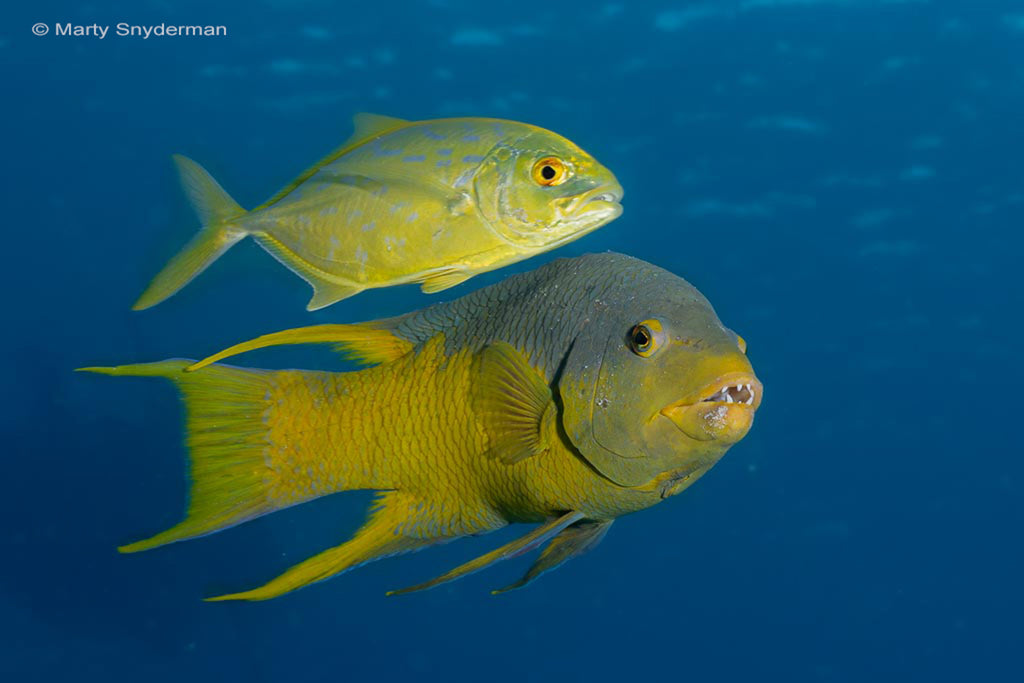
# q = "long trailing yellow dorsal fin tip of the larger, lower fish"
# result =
<box><xmin>185</xmin><ymin>323</ymin><xmax>413</xmax><ymax>373</ymax></box>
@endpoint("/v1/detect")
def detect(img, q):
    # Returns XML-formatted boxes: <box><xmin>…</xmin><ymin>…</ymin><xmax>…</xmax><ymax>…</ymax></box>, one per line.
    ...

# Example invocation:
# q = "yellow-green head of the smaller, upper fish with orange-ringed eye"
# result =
<box><xmin>474</xmin><ymin>125</ymin><xmax>623</xmax><ymax>251</ymax></box>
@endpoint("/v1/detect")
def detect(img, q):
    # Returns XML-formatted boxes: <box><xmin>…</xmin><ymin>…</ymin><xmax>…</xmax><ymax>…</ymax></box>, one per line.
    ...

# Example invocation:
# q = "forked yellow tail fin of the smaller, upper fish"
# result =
<box><xmin>132</xmin><ymin>155</ymin><xmax>247</xmax><ymax>310</ymax></box>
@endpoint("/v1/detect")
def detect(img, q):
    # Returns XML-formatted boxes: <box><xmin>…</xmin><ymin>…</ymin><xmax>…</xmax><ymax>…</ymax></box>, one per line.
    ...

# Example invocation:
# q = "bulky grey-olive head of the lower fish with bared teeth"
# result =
<box><xmin>559</xmin><ymin>259</ymin><xmax>762</xmax><ymax>493</ymax></box>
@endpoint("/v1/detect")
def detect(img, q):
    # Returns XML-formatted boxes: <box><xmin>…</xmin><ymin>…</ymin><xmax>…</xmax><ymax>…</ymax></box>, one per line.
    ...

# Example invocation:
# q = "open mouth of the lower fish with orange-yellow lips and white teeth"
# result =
<box><xmin>659</xmin><ymin>373</ymin><xmax>764</xmax><ymax>443</ymax></box>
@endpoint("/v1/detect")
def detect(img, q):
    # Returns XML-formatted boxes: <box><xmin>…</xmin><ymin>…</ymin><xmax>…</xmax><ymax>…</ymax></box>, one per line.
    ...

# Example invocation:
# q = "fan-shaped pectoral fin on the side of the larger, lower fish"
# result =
<box><xmin>474</xmin><ymin>342</ymin><xmax>556</xmax><ymax>465</ymax></box>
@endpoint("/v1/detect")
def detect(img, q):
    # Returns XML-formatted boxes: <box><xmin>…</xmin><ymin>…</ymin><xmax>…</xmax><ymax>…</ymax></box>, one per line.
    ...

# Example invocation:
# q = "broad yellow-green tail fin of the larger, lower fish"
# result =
<box><xmin>81</xmin><ymin>359</ymin><xmax>299</xmax><ymax>553</ymax></box>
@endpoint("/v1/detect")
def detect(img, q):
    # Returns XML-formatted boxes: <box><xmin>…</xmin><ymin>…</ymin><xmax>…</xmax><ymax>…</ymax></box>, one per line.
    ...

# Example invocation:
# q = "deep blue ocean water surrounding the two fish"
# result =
<box><xmin>0</xmin><ymin>0</ymin><xmax>1024</xmax><ymax>683</ymax></box>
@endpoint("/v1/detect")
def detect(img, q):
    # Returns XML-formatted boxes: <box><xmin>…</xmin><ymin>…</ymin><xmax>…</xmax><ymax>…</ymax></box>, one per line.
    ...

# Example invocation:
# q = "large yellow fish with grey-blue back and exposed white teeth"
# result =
<box><xmin>84</xmin><ymin>254</ymin><xmax>762</xmax><ymax>600</ymax></box>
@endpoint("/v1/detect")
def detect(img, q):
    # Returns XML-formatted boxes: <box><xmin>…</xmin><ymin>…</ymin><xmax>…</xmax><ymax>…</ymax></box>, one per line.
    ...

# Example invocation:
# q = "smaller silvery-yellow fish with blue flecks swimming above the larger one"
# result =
<box><xmin>134</xmin><ymin>114</ymin><xmax>623</xmax><ymax>310</ymax></box>
